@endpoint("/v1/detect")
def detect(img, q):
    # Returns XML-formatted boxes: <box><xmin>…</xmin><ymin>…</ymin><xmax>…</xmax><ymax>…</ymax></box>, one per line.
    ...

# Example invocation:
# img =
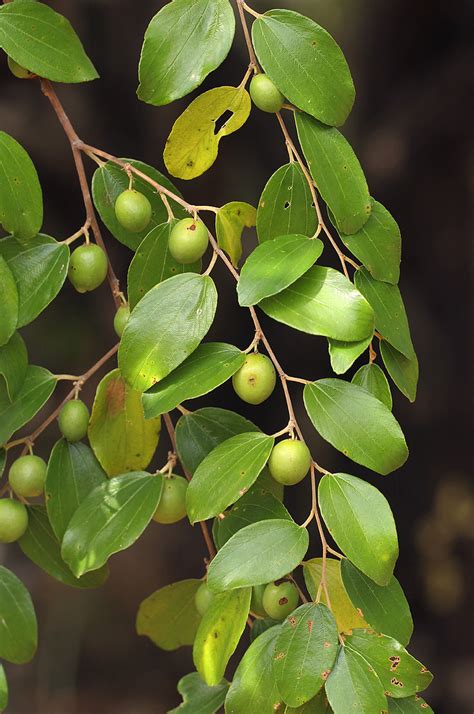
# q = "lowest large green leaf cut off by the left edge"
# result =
<box><xmin>0</xmin><ymin>565</ymin><xmax>38</xmax><ymax>664</ymax></box>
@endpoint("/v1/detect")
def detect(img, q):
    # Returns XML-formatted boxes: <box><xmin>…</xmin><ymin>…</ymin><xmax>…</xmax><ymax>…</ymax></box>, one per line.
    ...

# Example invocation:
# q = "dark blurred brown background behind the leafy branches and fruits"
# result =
<box><xmin>0</xmin><ymin>0</ymin><xmax>474</xmax><ymax>714</ymax></box>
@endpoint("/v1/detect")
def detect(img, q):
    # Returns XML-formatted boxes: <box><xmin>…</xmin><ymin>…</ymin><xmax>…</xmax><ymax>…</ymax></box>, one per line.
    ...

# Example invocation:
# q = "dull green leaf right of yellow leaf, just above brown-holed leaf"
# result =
<box><xmin>341</xmin><ymin>559</ymin><xmax>413</xmax><ymax>646</ymax></box>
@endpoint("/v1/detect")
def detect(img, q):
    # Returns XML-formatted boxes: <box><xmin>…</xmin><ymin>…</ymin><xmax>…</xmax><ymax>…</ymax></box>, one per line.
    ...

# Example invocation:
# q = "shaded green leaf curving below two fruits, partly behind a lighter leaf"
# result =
<box><xmin>18</xmin><ymin>506</ymin><xmax>109</xmax><ymax>588</ymax></box>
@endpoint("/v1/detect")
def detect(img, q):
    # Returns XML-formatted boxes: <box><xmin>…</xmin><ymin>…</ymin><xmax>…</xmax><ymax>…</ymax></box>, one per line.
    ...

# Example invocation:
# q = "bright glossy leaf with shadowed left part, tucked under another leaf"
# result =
<box><xmin>260</xmin><ymin>265</ymin><xmax>374</xmax><ymax>342</ymax></box>
